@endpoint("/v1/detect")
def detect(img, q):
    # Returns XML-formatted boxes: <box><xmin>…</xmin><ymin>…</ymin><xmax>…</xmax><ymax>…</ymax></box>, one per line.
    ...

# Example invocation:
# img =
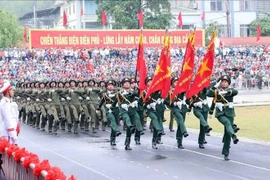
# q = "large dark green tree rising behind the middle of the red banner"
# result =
<box><xmin>96</xmin><ymin>0</ymin><xmax>173</xmax><ymax>29</ymax></box>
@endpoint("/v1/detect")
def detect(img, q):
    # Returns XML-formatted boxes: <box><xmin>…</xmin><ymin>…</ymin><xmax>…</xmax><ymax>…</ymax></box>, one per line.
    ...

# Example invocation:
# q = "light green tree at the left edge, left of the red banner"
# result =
<box><xmin>0</xmin><ymin>9</ymin><xmax>23</xmax><ymax>48</ymax></box>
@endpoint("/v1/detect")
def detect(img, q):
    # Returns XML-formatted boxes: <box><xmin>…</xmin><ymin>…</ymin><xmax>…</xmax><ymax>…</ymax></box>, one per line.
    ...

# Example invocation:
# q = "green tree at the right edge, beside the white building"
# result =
<box><xmin>249</xmin><ymin>12</ymin><xmax>270</xmax><ymax>36</ymax></box>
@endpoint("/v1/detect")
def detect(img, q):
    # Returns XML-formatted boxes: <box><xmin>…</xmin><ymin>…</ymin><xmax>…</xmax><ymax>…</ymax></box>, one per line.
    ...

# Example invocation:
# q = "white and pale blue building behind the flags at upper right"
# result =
<box><xmin>173</xmin><ymin>0</ymin><xmax>270</xmax><ymax>37</ymax></box>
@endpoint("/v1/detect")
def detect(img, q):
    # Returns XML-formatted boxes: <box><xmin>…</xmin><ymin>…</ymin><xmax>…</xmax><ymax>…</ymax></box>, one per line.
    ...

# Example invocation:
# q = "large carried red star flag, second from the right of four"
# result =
<box><xmin>172</xmin><ymin>32</ymin><xmax>195</xmax><ymax>98</ymax></box>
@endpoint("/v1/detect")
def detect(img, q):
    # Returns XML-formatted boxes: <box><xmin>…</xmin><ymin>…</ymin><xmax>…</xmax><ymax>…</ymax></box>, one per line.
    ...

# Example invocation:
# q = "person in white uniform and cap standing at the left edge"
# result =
<box><xmin>0</xmin><ymin>80</ymin><xmax>19</xmax><ymax>144</ymax></box>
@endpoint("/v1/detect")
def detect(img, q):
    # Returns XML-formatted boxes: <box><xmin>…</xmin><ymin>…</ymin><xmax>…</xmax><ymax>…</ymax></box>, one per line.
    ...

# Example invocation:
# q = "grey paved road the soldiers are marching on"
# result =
<box><xmin>16</xmin><ymin>91</ymin><xmax>270</xmax><ymax>180</ymax></box>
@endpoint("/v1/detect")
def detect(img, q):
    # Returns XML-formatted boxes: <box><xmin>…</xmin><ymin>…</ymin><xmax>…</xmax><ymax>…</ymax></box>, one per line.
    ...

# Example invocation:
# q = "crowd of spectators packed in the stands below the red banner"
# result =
<box><xmin>0</xmin><ymin>45</ymin><xmax>270</xmax><ymax>89</ymax></box>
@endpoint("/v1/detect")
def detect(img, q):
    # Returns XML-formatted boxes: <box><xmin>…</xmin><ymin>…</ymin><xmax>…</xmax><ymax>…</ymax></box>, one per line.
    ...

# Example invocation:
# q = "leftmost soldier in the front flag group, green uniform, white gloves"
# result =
<box><xmin>97</xmin><ymin>80</ymin><xmax>121</xmax><ymax>146</ymax></box>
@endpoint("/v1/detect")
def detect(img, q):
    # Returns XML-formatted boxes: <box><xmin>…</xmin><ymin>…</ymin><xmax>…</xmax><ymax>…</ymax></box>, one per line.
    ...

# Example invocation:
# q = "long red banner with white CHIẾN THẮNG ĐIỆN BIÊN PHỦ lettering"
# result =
<box><xmin>29</xmin><ymin>29</ymin><xmax>205</xmax><ymax>48</ymax></box>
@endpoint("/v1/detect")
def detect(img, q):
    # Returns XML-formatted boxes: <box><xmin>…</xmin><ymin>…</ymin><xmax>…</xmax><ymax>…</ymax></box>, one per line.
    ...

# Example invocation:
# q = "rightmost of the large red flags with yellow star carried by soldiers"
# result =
<box><xmin>186</xmin><ymin>31</ymin><xmax>216</xmax><ymax>98</ymax></box>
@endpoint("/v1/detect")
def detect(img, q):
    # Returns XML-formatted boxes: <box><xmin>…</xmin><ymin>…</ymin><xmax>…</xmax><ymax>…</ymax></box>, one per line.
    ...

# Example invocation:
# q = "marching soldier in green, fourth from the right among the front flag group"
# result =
<box><xmin>141</xmin><ymin>76</ymin><xmax>163</xmax><ymax>149</ymax></box>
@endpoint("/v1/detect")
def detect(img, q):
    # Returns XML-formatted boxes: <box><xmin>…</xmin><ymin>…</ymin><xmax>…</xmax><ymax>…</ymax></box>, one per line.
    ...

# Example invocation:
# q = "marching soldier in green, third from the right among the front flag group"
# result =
<box><xmin>165</xmin><ymin>77</ymin><xmax>188</xmax><ymax>149</ymax></box>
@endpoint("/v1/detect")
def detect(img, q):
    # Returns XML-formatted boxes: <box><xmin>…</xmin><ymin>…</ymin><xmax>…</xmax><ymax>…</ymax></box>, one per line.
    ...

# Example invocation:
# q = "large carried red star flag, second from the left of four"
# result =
<box><xmin>145</xmin><ymin>34</ymin><xmax>171</xmax><ymax>100</ymax></box>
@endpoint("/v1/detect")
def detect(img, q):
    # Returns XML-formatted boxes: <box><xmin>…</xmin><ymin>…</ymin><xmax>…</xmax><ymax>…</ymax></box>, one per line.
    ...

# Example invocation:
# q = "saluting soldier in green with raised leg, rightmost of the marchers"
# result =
<box><xmin>206</xmin><ymin>75</ymin><xmax>239</xmax><ymax>161</ymax></box>
